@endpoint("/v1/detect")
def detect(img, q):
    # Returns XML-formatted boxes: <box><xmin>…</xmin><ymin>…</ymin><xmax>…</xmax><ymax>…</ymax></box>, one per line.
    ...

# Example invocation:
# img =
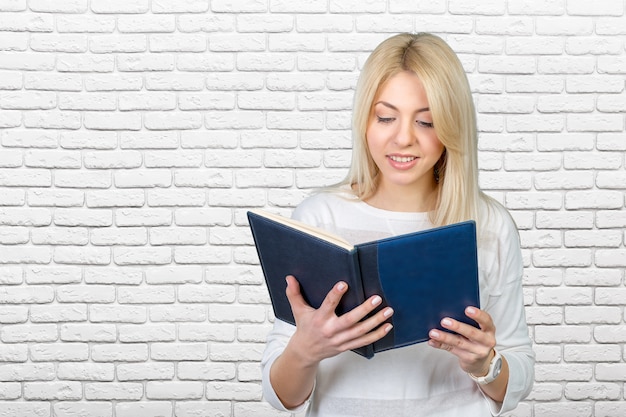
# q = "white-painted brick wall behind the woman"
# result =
<box><xmin>0</xmin><ymin>0</ymin><xmax>626</xmax><ymax>417</ymax></box>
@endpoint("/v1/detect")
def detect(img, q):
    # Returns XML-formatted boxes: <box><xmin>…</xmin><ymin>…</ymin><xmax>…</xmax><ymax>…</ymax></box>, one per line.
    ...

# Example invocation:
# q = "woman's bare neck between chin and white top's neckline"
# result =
<box><xmin>365</xmin><ymin>181</ymin><xmax>438</xmax><ymax>213</ymax></box>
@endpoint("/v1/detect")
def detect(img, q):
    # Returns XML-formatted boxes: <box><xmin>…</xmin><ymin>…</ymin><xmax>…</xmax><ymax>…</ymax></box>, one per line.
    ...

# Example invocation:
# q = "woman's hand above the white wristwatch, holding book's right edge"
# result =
<box><xmin>428</xmin><ymin>307</ymin><xmax>496</xmax><ymax>376</ymax></box>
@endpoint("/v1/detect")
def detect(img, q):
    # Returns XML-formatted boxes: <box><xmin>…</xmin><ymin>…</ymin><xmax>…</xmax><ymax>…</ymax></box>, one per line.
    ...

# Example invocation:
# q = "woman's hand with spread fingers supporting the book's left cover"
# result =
<box><xmin>286</xmin><ymin>275</ymin><xmax>393</xmax><ymax>366</ymax></box>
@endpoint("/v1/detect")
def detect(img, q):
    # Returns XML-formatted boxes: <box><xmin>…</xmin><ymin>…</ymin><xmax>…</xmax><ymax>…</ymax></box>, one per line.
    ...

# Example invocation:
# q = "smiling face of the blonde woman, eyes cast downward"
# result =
<box><xmin>366</xmin><ymin>71</ymin><xmax>444</xmax><ymax>195</ymax></box>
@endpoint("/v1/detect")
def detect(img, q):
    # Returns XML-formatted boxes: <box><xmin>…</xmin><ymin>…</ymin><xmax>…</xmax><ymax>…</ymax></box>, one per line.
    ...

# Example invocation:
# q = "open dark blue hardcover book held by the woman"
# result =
<box><xmin>248</xmin><ymin>210</ymin><xmax>480</xmax><ymax>358</ymax></box>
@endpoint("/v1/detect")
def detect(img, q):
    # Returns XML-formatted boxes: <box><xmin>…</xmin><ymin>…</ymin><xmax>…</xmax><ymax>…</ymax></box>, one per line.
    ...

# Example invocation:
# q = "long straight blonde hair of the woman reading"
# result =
<box><xmin>339</xmin><ymin>33</ymin><xmax>488</xmax><ymax>226</ymax></box>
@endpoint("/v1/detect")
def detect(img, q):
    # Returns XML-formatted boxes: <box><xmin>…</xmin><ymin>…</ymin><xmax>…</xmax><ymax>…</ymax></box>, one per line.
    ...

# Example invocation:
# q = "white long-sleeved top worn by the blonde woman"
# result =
<box><xmin>261</xmin><ymin>193</ymin><xmax>534</xmax><ymax>417</ymax></box>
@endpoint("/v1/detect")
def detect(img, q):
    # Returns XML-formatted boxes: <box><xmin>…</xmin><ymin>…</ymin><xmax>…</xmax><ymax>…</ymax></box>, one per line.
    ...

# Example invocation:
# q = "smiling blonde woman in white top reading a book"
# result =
<box><xmin>262</xmin><ymin>34</ymin><xmax>534</xmax><ymax>417</ymax></box>
